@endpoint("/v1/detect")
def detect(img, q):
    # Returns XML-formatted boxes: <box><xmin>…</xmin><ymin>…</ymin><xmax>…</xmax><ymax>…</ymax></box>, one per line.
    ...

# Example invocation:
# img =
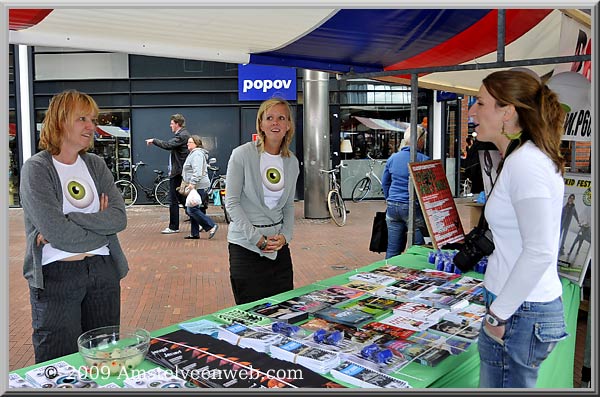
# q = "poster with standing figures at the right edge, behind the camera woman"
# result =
<box><xmin>558</xmin><ymin>172</ymin><xmax>592</xmax><ymax>286</ymax></box>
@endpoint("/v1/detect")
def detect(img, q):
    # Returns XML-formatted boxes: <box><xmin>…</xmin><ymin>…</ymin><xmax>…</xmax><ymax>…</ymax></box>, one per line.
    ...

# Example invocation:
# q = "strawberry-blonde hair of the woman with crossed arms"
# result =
<box><xmin>39</xmin><ymin>90</ymin><xmax>99</xmax><ymax>155</ymax></box>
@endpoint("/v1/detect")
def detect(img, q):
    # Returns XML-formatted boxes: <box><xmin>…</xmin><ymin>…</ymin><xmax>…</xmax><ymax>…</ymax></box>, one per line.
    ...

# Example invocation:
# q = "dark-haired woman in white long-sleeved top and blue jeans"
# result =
<box><xmin>469</xmin><ymin>71</ymin><xmax>568</xmax><ymax>388</ymax></box>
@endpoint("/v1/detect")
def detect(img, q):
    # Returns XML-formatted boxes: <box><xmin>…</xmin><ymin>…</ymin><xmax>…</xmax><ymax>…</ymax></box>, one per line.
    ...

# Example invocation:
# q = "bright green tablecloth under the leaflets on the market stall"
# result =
<box><xmin>14</xmin><ymin>246</ymin><xmax>580</xmax><ymax>389</ymax></box>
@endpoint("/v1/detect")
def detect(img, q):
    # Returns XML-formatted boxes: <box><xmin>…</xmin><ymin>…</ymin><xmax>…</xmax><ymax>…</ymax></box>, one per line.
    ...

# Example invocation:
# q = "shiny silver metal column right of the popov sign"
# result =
<box><xmin>303</xmin><ymin>70</ymin><xmax>331</xmax><ymax>219</ymax></box>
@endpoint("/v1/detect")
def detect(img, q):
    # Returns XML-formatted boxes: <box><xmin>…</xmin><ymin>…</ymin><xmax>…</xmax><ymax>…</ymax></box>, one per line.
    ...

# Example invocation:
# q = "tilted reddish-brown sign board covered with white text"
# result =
<box><xmin>408</xmin><ymin>160</ymin><xmax>465</xmax><ymax>249</ymax></box>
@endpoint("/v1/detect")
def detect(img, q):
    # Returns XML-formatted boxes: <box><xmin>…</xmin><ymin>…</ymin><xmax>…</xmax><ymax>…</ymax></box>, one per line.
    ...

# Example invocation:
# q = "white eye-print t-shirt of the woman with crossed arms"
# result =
<box><xmin>42</xmin><ymin>156</ymin><xmax>110</xmax><ymax>265</ymax></box>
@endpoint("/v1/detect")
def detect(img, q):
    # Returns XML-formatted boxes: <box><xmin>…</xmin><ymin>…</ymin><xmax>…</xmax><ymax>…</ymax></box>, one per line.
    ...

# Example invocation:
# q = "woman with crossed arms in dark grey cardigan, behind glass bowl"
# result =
<box><xmin>20</xmin><ymin>90</ymin><xmax>129</xmax><ymax>363</ymax></box>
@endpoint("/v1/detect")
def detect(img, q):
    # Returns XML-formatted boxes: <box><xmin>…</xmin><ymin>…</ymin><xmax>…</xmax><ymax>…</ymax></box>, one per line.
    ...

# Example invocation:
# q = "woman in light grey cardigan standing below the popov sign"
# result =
<box><xmin>225</xmin><ymin>98</ymin><xmax>300</xmax><ymax>305</ymax></box>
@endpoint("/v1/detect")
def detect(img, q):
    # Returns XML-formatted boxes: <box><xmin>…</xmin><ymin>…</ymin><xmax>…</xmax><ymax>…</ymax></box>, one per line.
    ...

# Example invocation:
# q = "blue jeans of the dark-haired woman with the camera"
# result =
<box><xmin>478</xmin><ymin>290</ymin><xmax>569</xmax><ymax>388</ymax></box>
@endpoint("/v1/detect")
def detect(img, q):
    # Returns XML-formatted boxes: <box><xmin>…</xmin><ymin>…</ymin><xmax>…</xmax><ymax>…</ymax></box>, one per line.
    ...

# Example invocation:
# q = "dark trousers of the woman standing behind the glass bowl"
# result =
<box><xmin>29</xmin><ymin>255</ymin><xmax>121</xmax><ymax>363</ymax></box>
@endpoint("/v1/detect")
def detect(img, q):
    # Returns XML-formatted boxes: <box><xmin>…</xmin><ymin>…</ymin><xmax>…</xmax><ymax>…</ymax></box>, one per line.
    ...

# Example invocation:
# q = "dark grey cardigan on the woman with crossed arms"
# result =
<box><xmin>20</xmin><ymin>150</ymin><xmax>129</xmax><ymax>288</ymax></box>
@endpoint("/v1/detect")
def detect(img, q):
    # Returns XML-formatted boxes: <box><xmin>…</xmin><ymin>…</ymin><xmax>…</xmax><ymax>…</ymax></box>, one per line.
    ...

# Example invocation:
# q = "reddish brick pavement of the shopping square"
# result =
<box><xmin>9</xmin><ymin>201</ymin><xmax>586</xmax><ymax>385</ymax></box>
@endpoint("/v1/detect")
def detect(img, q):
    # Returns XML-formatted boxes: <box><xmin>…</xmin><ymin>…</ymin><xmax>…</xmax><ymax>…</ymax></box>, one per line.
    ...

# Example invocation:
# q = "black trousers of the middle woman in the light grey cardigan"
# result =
<box><xmin>229</xmin><ymin>243</ymin><xmax>294</xmax><ymax>305</ymax></box>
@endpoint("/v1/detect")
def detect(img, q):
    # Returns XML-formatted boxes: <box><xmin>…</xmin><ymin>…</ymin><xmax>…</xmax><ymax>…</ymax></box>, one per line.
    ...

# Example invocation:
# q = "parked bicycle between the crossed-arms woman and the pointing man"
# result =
<box><xmin>115</xmin><ymin>161</ymin><xmax>169</xmax><ymax>208</ymax></box>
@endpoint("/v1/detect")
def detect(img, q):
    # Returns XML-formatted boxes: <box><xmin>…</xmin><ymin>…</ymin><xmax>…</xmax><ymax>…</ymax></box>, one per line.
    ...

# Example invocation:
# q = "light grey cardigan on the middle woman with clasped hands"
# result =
<box><xmin>225</xmin><ymin>142</ymin><xmax>300</xmax><ymax>259</ymax></box>
